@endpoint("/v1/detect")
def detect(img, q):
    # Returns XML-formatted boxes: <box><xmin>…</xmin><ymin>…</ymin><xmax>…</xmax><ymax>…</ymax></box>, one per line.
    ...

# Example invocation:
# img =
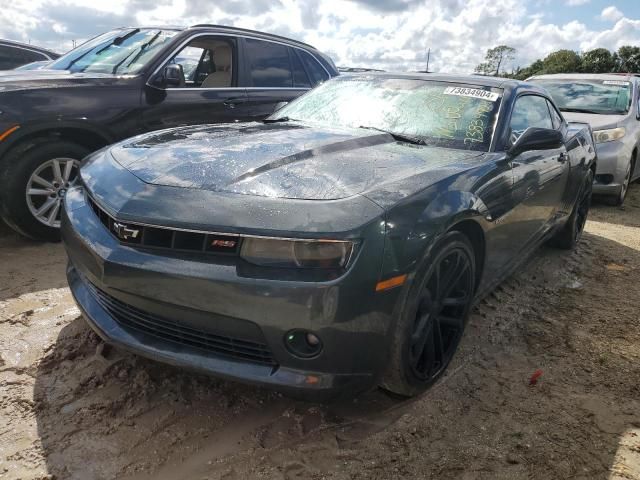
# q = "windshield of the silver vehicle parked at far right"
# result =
<box><xmin>533</xmin><ymin>79</ymin><xmax>632</xmax><ymax>115</ymax></box>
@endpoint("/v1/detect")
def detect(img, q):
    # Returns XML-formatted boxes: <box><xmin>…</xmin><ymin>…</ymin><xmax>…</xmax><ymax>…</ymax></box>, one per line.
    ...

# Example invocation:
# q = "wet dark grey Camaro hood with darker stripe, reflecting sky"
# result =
<box><xmin>110</xmin><ymin>123</ymin><xmax>481</xmax><ymax>200</ymax></box>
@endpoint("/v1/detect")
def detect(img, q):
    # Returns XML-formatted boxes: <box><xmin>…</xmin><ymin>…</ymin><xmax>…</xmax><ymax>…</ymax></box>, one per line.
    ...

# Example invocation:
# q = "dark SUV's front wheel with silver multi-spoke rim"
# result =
<box><xmin>0</xmin><ymin>139</ymin><xmax>90</xmax><ymax>242</ymax></box>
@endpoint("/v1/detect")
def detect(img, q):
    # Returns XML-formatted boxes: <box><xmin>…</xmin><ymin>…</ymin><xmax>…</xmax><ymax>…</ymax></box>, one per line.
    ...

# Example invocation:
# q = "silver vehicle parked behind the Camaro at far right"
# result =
<box><xmin>529</xmin><ymin>73</ymin><xmax>640</xmax><ymax>205</ymax></box>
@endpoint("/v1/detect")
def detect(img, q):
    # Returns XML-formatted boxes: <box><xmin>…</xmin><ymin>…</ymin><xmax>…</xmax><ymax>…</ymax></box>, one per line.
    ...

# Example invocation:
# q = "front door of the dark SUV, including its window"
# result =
<box><xmin>142</xmin><ymin>35</ymin><xmax>249</xmax><ymax>131</ymax></box>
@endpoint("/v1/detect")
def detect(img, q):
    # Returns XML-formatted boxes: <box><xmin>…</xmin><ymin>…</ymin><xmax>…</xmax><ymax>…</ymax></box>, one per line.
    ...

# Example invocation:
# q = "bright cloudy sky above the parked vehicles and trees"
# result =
<box><xmin>0</xmin><ymin>0</ymin><xmax>640</xmax><ymax>73</ymax></box>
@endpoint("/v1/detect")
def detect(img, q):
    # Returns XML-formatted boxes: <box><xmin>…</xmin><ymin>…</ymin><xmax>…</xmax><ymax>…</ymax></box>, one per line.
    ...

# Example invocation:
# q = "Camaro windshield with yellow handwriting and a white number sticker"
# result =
<box><xmin>268</xmin><ymin>76</ymin><xmax>502</xmax><ymax>151</ymax></box>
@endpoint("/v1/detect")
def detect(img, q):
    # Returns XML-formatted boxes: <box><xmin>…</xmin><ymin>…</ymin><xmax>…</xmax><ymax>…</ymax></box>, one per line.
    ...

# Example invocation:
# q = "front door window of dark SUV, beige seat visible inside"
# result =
<box><xmin>169</xmin><ymin>37</ymin><xmax>235</xmax><ymax>88</ymax></box>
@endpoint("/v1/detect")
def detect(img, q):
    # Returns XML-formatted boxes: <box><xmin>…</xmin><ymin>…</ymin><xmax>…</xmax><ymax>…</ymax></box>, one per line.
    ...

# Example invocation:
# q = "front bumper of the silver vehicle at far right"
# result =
<box><xmin>593</xmin><ymin>140</ymin><xmax>633</xmax><ymax>195</ymax></box>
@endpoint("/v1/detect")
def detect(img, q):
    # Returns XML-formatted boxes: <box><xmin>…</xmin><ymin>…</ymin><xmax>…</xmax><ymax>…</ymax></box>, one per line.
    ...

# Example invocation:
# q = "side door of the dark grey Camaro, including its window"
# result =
<box><xmin>510</xmin><ymin>94</ymin><xmax>569</xmax><ymax>250</ymax></box>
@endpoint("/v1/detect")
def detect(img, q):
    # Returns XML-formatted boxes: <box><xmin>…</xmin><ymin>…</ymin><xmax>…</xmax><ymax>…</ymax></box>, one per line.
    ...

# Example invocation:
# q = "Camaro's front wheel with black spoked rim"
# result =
<box><xmin>380</xmin><ymin>231</ymin><xmax>476</xmax><ymax>397</ymax></box>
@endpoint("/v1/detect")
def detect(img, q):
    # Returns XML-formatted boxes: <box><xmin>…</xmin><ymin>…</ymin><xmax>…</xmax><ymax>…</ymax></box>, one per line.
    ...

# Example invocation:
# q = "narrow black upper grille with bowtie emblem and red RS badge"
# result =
<box><xmin>87</xmin><ymin>195</ymin><xmax>240</xmax><ymax>255</ymax></box>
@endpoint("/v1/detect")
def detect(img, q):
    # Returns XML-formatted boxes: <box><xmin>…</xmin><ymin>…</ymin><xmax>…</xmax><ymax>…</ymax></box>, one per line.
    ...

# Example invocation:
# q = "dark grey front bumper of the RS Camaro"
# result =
<box><xmin>61</xmin><ymin>190</ymin><xmax>402</xmax><ymax>398</ymax></box>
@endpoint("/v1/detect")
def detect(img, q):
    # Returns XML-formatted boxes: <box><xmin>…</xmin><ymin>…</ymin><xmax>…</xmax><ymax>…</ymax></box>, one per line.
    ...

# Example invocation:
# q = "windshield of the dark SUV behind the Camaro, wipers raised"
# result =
<box><xmin>47</xmin><ymin>28</ymin><xmax>178</xmax><ymax>75</ymax></box>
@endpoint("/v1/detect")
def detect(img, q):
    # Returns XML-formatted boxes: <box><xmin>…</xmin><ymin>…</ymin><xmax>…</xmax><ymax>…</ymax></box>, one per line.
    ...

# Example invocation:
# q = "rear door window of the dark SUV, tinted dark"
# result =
<box><xmin>246</xmin><ymin>39</ymin><xmax>293</xmax><ymax>88</ymax></box>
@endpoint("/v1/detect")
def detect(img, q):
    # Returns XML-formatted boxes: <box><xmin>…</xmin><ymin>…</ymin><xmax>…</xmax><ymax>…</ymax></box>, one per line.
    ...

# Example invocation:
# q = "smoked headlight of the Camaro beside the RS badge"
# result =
<box><xmin>240</xmin><ymin>238</ymin><xmax>353</xmax><ymax>268</ymax></box>
